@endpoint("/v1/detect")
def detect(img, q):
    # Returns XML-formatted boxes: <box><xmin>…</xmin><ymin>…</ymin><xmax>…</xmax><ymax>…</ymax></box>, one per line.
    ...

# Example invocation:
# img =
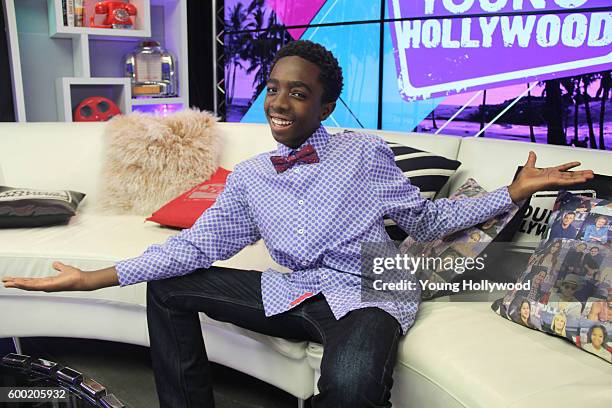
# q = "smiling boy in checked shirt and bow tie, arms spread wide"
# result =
<box><xmin>3</xmin><ymin>41</ymin><xmax>592</xmax><ymax>408</ymax></box>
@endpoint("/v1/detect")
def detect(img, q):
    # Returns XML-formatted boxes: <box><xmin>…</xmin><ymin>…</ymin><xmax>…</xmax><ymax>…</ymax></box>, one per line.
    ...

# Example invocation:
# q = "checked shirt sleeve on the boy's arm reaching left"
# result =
<box><xmin>115</xmin><ymin>167</ymin><xmax>260</xmax><ymax>286</ymax></box>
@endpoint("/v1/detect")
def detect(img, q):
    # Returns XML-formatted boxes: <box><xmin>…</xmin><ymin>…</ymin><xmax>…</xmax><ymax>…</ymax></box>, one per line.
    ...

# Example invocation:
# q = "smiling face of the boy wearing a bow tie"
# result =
<box><xmin>264</xmin><ymin>56</ymin><xmax>336</xmax><ymax>148</ymax></box>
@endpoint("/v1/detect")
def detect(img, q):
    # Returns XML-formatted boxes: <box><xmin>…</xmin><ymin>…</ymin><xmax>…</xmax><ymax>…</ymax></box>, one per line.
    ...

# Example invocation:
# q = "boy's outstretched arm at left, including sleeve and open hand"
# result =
<box><xmin>2</xmin><ymin>167</ymin><xmax>260</xmax><ymax>292</ymax></box>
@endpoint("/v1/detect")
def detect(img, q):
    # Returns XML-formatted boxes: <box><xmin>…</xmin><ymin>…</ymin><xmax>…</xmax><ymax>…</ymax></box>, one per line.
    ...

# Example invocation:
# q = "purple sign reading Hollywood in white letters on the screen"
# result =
<box><xmin>388</xmin><ymin>0</ymin><xmax>612</xmax><ymax>100</ymax></box>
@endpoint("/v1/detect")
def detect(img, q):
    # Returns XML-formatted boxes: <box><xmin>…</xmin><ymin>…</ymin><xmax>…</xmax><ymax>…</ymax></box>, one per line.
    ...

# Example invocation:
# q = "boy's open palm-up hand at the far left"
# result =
<box><xmin>2</xmin><ymin>262</ymin><xmax>88</xmax><ymax>292</ymax></box>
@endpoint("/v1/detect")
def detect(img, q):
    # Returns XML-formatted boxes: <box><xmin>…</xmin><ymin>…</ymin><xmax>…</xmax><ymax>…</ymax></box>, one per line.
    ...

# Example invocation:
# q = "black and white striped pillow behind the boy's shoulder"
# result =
<box><xmin>385</xmin><ymin>142</ymin><xmax>461</xmax><ymax>240</ymax></box>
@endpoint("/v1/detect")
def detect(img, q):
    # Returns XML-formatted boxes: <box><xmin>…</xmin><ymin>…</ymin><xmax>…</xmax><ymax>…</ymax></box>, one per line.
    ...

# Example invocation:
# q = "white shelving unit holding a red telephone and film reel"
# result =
<box><xmin>4</xmin><ymin>0</ymin><xmax>189</xmax><ymax>122</ymax></box>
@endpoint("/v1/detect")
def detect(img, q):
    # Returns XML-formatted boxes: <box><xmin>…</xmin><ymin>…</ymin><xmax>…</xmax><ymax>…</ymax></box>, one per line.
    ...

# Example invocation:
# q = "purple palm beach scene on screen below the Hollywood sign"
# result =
<box><xmin>415</xmin><ymin>77</ymin><xmax>612</xmax><ymax>150</ymax></box>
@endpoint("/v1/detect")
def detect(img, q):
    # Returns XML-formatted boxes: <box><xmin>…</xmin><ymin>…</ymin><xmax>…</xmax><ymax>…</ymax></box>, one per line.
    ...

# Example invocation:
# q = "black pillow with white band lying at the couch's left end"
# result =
<box><xmin>0</xmin><ymin>186</ymin><xmax>85</xmax><ymax>228</ymax></box>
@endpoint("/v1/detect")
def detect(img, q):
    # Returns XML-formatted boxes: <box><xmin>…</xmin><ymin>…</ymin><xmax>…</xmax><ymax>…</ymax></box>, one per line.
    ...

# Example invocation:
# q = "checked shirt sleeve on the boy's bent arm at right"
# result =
<box><xmin>369</xmin><ymin>138</ymin><xmax>515</xmax><ymax>242</ymax></box>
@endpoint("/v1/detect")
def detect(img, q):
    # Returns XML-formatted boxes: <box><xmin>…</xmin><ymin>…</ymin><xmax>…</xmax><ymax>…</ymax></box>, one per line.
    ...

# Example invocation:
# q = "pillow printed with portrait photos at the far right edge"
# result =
<box><xmin>492</xmin><ymin>192</ymin><xmax>612</xmax><ymax>363</ymax></box>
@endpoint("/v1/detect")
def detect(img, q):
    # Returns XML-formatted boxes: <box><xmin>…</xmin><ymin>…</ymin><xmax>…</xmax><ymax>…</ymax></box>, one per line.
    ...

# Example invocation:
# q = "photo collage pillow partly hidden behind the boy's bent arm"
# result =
<box><xmin>399</xmin><ymin>178</ymin><xmax>519</xmax><ymax>300</ymax></box>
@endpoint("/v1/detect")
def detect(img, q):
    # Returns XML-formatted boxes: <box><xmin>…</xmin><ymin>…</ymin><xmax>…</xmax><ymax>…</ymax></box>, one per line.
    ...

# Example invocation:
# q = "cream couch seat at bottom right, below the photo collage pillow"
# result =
<box><xmin>396</xmin><ymin>302</ymin><xmax>612</xmax><ymax>407</ymax></box>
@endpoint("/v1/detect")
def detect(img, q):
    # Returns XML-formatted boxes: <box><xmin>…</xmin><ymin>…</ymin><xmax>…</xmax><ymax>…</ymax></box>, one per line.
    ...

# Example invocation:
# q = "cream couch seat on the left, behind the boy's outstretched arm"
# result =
<box><xmin>0</xmin><ymin>212</ymin><xmax>286</xmax><ymax>306</ymax></box>
